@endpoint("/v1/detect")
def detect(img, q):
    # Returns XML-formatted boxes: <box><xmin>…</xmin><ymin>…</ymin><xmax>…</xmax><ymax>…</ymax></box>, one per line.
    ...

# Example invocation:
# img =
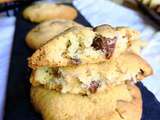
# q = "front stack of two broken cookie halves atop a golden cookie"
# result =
<box><xmin>29</xmin><ymin>25</ymin><xmax>152</xmax><ymax>120</ymax></box>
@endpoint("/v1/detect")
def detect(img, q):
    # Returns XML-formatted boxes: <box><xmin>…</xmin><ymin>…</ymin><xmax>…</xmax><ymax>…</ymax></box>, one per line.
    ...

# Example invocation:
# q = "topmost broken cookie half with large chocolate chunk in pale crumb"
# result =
<box><xmin>29</xmin><ymin>27</ymin><xmax>144</xmax><ymax>69</ymax></box>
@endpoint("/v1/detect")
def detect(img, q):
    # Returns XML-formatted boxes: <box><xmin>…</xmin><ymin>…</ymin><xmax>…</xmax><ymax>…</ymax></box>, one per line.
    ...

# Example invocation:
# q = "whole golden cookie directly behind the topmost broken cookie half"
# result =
<box><xmin>26</xmin><ymin>19</ymin><xmax>82</xmax><ymax>49</ymax></box>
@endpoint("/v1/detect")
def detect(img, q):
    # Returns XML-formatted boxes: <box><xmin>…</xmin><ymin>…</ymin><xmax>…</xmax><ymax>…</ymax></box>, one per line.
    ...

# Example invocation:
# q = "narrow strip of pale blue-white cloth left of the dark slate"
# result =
<box><xmin>0</xmin><ymin>17</ymin><xmax>15</xmax><ymax>120</ymax></box>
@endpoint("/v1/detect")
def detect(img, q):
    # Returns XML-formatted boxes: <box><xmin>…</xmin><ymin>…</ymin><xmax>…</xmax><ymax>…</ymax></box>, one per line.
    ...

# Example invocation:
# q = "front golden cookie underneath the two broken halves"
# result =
<box><xmin>31</xmin><ymin>84</ymin><xmax>142</xmax><ymax>120</ymax></box>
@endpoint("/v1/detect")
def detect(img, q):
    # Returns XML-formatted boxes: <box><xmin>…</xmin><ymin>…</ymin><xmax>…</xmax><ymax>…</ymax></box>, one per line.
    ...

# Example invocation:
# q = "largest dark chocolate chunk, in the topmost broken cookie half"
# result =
<box><xmin>91</xmin><ymin>35</ymin><xmax>117</xmax><ymax>59</ymax></box>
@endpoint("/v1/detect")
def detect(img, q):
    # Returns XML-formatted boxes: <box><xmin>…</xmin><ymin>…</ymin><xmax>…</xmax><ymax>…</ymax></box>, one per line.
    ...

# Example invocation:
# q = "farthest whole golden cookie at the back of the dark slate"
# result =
<box><xmin>23</xmin><ymin>2</ymin><xmax>77</xmax><ymax>23</ymax></box>
